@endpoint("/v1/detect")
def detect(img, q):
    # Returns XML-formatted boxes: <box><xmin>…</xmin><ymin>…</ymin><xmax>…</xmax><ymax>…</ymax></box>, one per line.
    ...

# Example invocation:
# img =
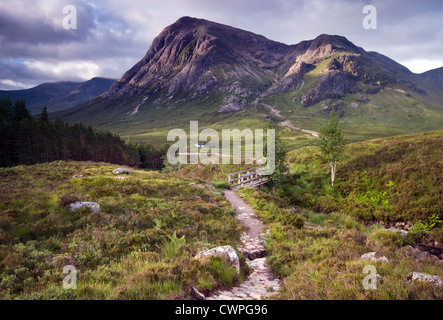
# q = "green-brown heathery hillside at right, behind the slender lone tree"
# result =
<box><xmin>285</xmin><ymin>130</ymin><xmax>443</xmax><ymax>221</ymax></box>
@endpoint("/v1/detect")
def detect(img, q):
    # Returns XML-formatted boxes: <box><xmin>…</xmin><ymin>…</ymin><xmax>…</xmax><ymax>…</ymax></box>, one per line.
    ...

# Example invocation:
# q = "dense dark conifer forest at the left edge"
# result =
<box><xmin>0</xmin><ymin>99</ymin><xmax>167</xmax><ymax>169</ymax></box>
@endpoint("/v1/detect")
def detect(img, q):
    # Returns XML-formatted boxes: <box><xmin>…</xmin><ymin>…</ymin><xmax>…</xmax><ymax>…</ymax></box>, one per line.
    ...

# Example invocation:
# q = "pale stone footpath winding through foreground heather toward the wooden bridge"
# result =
<box><xmin>206</xmin><ymin>190</ymin><xmax>281</xmax><ymax>300</ymax></box>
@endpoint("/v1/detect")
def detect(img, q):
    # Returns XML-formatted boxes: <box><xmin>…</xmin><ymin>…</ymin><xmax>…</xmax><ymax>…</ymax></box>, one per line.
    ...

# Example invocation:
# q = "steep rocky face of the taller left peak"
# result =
<box><xmin>104</xmin><ymin>17</ymin><xmax>291</xmax><ymax>104</ymax></box>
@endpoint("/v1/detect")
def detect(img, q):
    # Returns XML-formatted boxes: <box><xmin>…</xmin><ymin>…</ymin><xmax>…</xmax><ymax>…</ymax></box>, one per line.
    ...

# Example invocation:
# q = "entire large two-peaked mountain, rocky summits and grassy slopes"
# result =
<box><xmin>57</xmin><ymin>17</ymin><xmax>443</xmax><ymax>143</ymax></box>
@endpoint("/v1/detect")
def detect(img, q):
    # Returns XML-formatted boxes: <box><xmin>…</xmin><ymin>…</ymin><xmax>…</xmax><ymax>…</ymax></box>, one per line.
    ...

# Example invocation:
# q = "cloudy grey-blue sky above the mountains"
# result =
<box><xmin>0</xmin><ymin>0</ymin><xmax>443</xmax><ymax>89</ymax></box>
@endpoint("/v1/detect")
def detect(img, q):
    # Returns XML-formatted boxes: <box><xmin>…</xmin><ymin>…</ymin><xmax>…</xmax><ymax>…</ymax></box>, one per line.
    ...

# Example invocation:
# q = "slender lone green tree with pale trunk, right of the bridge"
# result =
<box><xmin>318</xmin><ymin>110</ymin><xmax>345</xmax><ymax>186</ymax></box>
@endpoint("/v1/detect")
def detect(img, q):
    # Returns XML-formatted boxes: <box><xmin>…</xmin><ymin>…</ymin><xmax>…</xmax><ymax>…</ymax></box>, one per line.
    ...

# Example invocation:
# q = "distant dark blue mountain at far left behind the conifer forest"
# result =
<box><xmin>0</xmin><ymin>78</ymin><xmax>115</xmax><ymax>114</ymax></box>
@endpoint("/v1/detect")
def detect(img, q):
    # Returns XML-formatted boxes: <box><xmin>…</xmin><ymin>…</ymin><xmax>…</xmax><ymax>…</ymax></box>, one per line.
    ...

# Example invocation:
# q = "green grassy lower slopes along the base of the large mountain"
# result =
<box><xmin>59</xmin><ymin>74</ymin><xmax>443</xmax><ymax>145</ymax></box>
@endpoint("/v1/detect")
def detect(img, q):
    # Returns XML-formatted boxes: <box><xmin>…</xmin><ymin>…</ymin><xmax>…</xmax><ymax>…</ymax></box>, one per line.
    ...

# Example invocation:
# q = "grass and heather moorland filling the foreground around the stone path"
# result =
<box><xmin>0</xmin><ymin>130</ymin><xmax>443</xmax><ymax>300</ymax></box>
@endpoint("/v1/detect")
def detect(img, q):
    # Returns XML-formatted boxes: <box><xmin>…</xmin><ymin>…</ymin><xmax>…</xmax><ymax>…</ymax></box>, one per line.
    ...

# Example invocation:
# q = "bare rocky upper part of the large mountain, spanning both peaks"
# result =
<box><xmin>98</xmin><ymin>17</ymin><xmax>434</xmax><ymax>112</ymax></box>
